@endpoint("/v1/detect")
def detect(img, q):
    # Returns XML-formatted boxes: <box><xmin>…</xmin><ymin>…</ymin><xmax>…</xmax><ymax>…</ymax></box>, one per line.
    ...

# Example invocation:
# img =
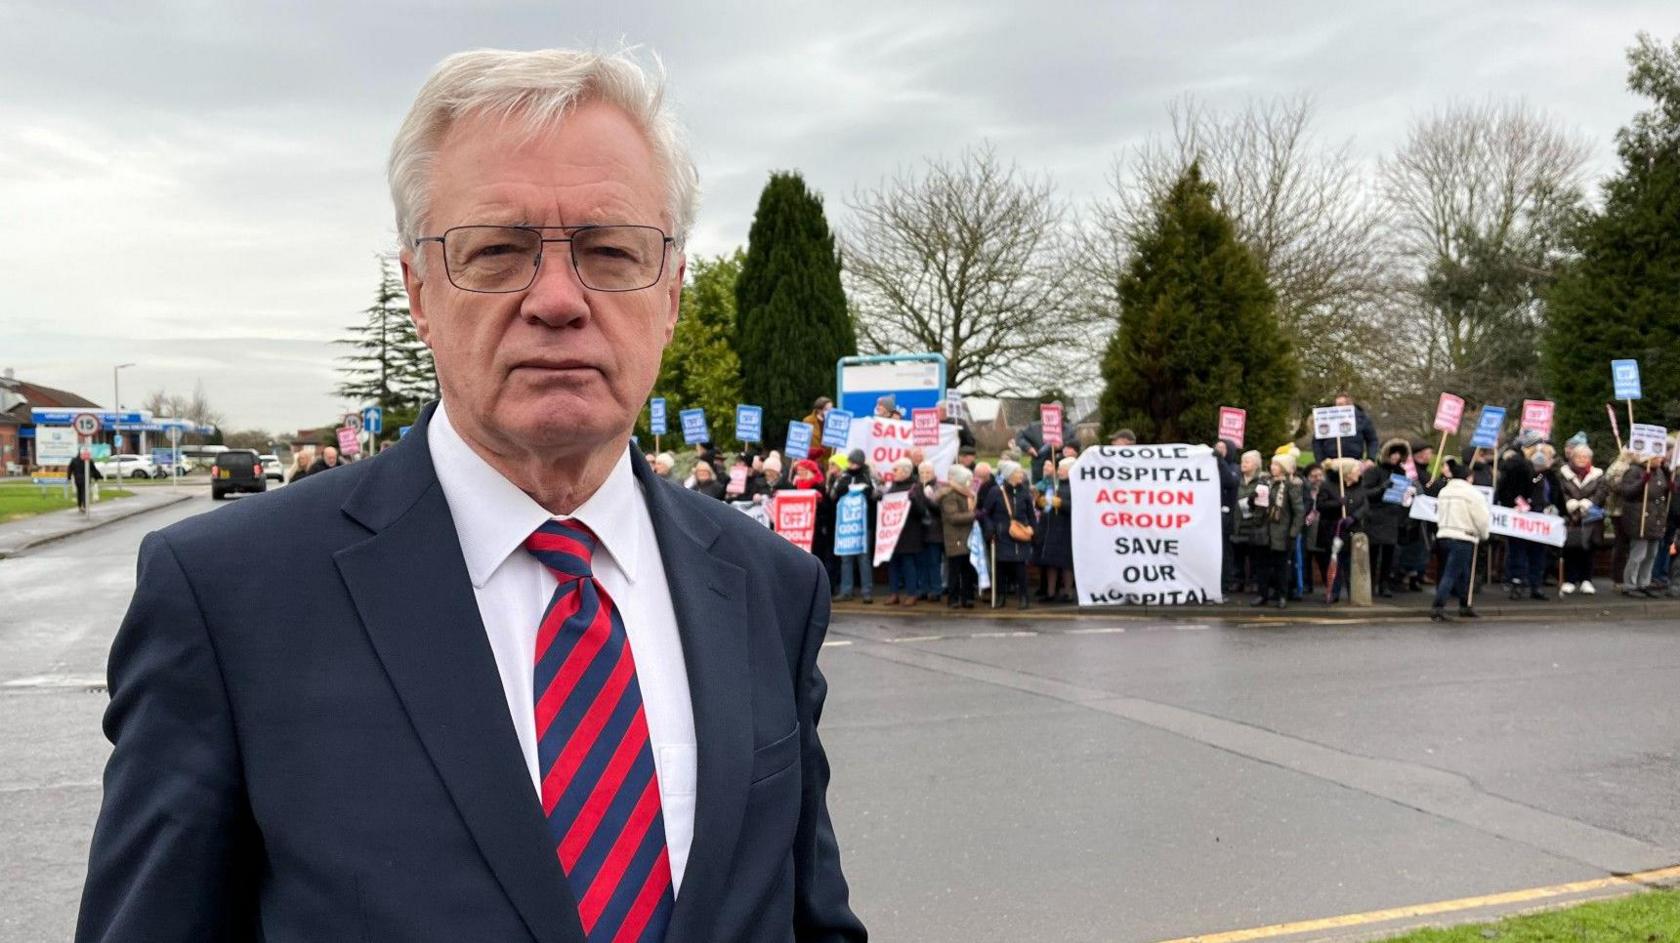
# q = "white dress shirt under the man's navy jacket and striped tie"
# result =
<box><xmin>427</xmin><ymin>403</ymin><xmax>697</xmax><ymax>893</ymax></box>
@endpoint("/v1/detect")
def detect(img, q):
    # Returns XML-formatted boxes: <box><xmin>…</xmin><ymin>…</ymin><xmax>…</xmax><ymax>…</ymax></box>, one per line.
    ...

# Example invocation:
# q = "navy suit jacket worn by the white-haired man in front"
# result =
<box><xmin>76</xmin><ymin>410</ymin><xmax>865</xmax><ymax>943</ymax></box>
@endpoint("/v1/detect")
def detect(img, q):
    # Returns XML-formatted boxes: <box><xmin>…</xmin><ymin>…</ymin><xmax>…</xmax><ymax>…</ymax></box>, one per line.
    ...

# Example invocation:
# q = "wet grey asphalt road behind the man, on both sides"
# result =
<box><xmin>0</xmin><ymin>498</ymin><xmax>1680</xmax><ymax>943</ymax></box>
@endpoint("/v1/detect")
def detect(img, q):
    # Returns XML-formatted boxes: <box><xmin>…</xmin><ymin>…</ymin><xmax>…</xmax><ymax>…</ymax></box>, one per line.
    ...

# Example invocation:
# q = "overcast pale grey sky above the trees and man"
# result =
<box><xmin>0</xmin><ymin>0</ymin><xmax>1680</xmax><ymax>430</ymax></box>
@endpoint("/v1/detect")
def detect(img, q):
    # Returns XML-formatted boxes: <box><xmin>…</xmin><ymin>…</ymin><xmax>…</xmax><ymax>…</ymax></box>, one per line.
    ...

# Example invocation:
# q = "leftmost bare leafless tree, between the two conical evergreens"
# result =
<box><xmin>842</xmin><ymin>145</ymin><xmax>1112</xmax><ymax>395</ymax></box>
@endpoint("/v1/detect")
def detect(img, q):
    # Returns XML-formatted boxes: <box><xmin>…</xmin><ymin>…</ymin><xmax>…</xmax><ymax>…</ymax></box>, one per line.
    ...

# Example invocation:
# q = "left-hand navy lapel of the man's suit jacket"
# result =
<box><xmin>334</xmin><ymin>408</ymin><xmax>588</xmax><ymax>943</ymax></box>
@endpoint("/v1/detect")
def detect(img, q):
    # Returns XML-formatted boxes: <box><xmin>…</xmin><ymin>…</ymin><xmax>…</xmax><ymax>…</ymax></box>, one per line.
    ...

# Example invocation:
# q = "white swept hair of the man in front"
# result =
<box><xmin>386</xmin><ymin>49</ymin><xmax>701</xmax><ymax>257</ymax></box>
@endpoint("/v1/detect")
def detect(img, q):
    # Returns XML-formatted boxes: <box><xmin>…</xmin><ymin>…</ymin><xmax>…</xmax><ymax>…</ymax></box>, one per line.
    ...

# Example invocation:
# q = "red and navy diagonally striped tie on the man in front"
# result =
<box><xmin>526</xmin><ymin>521</ymin><xmax>675</xmax><ymax>943</ymax></box>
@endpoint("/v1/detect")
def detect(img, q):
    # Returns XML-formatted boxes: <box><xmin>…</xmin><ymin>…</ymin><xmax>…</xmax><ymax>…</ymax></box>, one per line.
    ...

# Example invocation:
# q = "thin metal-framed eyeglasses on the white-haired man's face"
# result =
<box><xmin>415</xmin><ymin>225</ymin><xmax>674</xmax><ymax>294</ymax></box>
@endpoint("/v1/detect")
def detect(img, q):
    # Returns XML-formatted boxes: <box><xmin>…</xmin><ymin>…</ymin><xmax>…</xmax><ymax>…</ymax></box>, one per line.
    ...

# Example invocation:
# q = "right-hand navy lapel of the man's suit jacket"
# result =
<box><xmin>630</xmin><ymin>447</ymin><xmax>753</xmax><ymax>941</ymax></box>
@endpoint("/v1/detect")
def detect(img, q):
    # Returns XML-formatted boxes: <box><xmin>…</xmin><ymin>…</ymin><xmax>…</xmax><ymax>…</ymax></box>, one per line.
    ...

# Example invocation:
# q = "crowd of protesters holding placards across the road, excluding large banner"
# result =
<box><xmin>654</xmin><ymin>389</ymin><xmax>1680</xmax><ymax>620</ymax></box>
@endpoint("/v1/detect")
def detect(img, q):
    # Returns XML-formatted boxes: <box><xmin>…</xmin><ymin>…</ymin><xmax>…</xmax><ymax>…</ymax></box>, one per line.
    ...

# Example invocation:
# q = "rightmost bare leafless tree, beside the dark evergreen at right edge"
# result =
<box><xmin>1383</xmin><ymin>103</ymin><xmax>1589</xmax><ymax>422</ymax></box>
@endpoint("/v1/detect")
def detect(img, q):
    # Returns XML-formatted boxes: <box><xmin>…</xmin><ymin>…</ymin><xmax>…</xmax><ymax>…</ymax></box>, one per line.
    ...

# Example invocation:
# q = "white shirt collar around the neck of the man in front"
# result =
<box><xmin>427</xmin><ymin>402</ymin><xmax>642</xmax><ymax>588</ymax></box>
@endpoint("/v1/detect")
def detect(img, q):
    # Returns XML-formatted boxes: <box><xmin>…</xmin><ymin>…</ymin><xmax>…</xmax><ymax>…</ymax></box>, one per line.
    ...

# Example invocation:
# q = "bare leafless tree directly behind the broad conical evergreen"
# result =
<box><xmin>1085</xmin><ymin>96</ymin><xmax>1386</xmax><ymax>411</ymax></box>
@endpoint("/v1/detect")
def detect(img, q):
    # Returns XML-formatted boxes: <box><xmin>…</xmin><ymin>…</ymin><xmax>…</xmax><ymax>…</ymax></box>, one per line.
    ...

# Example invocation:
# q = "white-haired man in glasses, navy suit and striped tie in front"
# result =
<box><xmin>77</xmin><ymin>50</ymin><xmax>865</xmax><ymax>943</ymax></box>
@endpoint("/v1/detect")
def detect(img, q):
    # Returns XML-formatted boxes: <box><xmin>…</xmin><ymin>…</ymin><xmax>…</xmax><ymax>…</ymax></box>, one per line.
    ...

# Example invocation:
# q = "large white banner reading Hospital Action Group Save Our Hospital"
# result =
<box><xmin>1070</xmin><ymin>444</ymin><xmax>1223</xmax><ymax>605</ymax></box>
